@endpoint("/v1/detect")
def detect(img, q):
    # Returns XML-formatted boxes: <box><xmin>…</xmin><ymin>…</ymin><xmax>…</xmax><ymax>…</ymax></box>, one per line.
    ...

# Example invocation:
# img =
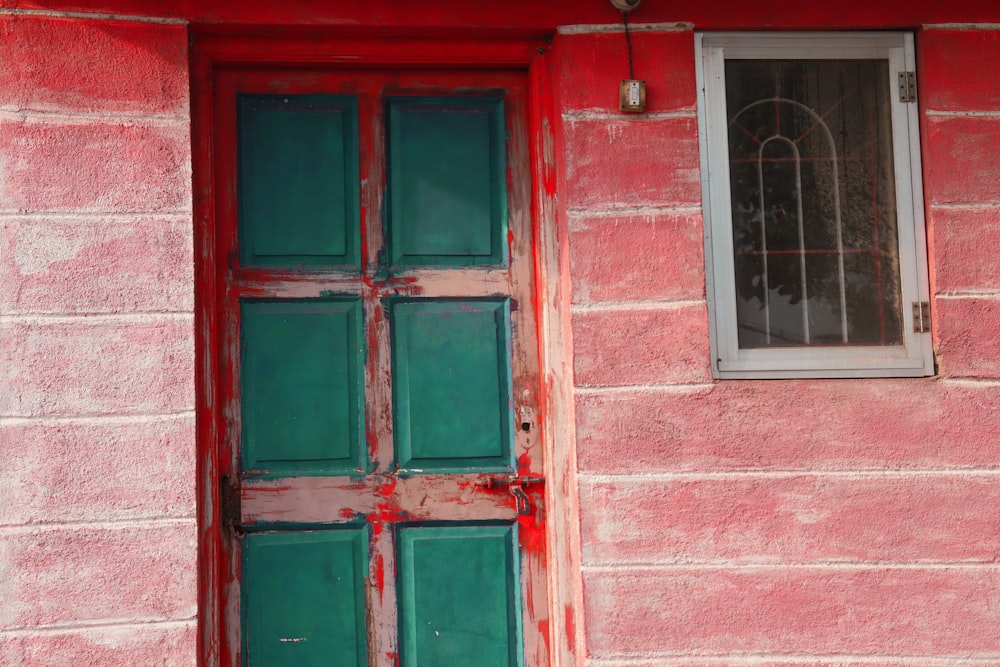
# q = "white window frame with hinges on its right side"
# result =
<box><xmin>695</xmin><ymin>32</ymin><xmax>934</xmax><ymax>379</ymax></box>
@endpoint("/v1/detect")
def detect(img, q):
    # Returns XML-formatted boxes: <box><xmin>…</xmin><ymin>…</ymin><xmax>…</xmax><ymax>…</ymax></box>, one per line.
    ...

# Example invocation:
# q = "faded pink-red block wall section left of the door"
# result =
<box><xmin>0</xmin><ymin>14</ymin><xmax>197</xmax><ymax>665</ymax></box>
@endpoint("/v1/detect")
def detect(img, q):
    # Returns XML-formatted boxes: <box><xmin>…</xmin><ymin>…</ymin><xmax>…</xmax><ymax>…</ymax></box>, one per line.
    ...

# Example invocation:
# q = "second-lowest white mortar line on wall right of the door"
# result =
<box><xmin>580</xmin><ymin>561</ymin><xmax>1000</xmax><ymax>574</ymax></box>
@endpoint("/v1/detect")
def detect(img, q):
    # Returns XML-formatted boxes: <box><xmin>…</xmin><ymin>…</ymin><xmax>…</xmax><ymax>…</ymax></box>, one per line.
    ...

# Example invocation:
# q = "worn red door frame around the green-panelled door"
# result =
<box><xmin>191</xmin><ymin>29</ymin><xmax>585</xmax><ymax>667</ymax></box>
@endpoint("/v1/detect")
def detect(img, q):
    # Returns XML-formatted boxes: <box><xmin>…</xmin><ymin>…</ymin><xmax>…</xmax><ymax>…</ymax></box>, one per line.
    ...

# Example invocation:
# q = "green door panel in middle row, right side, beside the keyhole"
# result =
<box><xmin>391</xmin><ymin>299</ymin><xmax>512</xmax><ymax>471</ymax></box>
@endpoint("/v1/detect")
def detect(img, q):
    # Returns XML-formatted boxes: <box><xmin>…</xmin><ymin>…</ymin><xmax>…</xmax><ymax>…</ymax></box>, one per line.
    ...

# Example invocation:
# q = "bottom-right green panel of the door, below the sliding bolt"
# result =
<box><xmin>397</xmin><ymin>525</ymin><xmax>521</xmax><ymax>667</ymax></box>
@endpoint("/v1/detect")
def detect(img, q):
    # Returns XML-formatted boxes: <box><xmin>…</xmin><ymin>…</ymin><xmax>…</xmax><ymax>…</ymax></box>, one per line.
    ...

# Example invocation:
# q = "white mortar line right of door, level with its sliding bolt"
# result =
<box><xmin>577</xmin><ymin>468</ymin><xmax>1000</xmax><ymax>483</ymax></box>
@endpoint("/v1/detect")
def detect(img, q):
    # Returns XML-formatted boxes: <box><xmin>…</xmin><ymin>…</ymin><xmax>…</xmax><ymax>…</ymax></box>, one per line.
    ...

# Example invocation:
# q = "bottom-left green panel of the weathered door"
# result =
<box><xmin>241</xmin><ymin>528</ymin><xmax>368</xmax><ymax>667</ymax></box>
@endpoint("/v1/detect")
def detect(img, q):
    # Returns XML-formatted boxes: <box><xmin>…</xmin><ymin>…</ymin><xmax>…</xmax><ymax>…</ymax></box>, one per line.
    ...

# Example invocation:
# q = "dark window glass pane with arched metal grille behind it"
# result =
<box><xmin>726</xmin><ymin>60</ymin><xmax>903</xmax><ymax>349</ymax></box>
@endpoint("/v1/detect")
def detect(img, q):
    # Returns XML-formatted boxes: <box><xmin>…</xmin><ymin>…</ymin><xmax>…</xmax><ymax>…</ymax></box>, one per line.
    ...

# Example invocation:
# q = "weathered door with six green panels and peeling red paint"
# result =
<box><xmin>213</xmin><ymin>69</ymin><xmax>547</xmax><ymax>667</ymax></box>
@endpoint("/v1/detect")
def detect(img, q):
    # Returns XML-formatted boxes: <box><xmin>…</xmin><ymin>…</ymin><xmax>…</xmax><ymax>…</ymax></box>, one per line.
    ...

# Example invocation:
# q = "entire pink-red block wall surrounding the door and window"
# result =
<box><xmin>0</xmin><ymin>0</ymin><xmax>1000</xmax><ymax>667</ymax></box>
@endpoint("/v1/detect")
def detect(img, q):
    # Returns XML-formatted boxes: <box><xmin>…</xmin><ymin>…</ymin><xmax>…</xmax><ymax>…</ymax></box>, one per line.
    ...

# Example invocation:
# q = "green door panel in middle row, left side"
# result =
<box><xmin>240</xmin><ymin>298</ymin><xmax>365</xmax><ymax>475</ymax></box>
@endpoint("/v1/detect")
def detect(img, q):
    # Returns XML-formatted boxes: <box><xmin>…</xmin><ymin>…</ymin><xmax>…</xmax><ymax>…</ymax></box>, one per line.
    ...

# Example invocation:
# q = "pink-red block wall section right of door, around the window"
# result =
<box><xmin>555</xmin><ymin>23</ymin><xmax>1000</xmax><ymax>667</ymax></box>
